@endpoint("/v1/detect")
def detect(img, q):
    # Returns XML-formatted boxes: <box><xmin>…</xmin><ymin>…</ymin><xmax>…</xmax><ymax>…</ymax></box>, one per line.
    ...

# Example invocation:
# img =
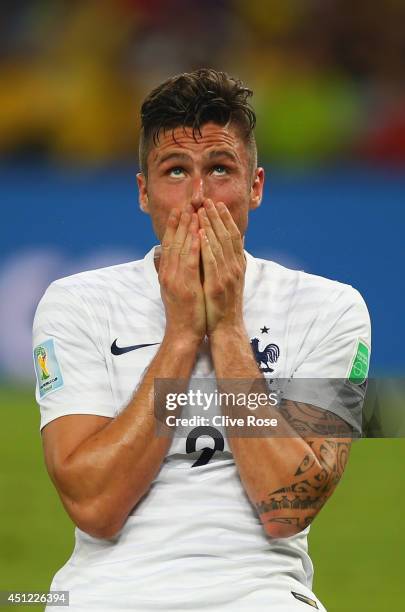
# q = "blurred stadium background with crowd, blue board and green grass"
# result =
<box><xmin>0</xmin><ymin>0</ymin><xmax>405</xmax><ymax>612</ymax></box>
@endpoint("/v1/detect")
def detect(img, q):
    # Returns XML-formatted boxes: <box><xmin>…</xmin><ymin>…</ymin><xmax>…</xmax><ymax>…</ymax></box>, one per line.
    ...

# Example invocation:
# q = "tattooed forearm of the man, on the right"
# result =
<box><xmin>211</xmin><ymin>329</ymin><xmax>333</xmax><ymax>537</ymax></box>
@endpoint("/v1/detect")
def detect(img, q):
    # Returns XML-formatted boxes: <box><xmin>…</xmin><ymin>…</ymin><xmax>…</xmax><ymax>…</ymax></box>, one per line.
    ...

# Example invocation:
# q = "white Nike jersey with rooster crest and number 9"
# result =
<box><xmin>34</xmin><ymin>248</ymin><xmax>370</xmax><ymax>611</ymax></box>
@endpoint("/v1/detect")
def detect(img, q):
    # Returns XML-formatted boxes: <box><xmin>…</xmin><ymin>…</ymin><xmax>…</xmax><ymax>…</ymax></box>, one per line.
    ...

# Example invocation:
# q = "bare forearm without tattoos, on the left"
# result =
<box><xmin>57</xmin><ymin>337</ymin><xmax>198</xmax><ymax>533</ymax></box>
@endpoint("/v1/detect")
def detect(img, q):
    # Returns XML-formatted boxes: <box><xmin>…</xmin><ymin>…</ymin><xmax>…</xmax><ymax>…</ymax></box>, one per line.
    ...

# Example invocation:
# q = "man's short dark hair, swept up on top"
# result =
<box><xmin>139</xmin><ymin>68</ymin><xmax>257</xmax><ymax>176</ymax></box>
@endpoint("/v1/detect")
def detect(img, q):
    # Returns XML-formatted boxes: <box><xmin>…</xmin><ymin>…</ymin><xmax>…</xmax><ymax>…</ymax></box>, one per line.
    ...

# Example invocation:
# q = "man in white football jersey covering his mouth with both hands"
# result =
<box><xmin>34</xmin><ymin>69</ymin><xmax>370</xmax><ymax>612</ymax></box>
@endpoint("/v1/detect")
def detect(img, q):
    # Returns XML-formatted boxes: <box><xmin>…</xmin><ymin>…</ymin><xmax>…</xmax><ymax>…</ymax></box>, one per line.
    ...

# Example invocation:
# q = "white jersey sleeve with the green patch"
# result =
<box><xmin>283</xmin><ymin>286</ymin><xmax>371</xmax><ymax>435</ymax></box>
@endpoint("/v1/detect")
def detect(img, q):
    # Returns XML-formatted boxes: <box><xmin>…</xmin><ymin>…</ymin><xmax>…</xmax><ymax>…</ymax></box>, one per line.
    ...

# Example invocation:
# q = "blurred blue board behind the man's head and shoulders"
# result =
<box><xmin>0</xmin><ymin>167</ymin><xmax>405</xmax><ymax>378</ymax></box>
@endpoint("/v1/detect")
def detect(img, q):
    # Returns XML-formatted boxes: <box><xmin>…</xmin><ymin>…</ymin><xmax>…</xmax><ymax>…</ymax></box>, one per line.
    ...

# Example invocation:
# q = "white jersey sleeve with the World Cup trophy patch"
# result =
<box><xmin>33</xmin><ymin>281</ymin><xmax>116</xmax><ymax>429</ymax></box>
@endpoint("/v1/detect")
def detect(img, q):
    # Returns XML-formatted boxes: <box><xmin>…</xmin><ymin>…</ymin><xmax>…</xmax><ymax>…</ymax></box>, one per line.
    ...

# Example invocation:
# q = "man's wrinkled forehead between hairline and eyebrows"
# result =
<box><xmin>148</xmin><ymin>123</ymin><xmax>246</xmax><ymax>164</ymax></box>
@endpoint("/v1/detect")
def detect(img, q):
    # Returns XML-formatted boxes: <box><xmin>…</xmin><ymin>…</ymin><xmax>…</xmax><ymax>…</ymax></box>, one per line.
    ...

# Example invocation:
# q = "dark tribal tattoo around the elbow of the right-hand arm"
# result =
<box><xmin>256</xmin><ymin>401</ymin><xmax>352</xmax><ymax>533</ymax></box>
